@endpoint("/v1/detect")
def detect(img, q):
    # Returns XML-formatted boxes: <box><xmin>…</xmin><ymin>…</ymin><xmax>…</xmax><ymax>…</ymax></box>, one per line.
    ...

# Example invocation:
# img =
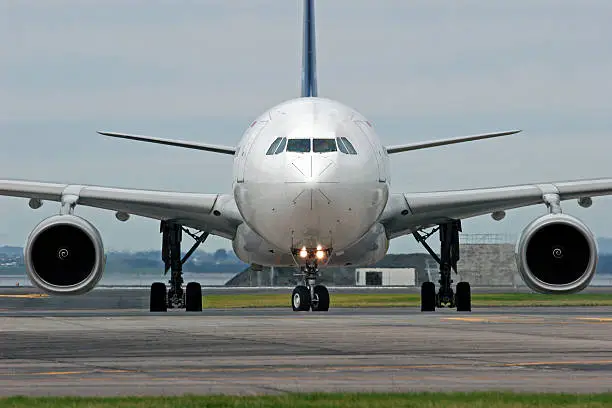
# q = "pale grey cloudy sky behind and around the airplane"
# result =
<box><xmin>0</xmin><ymin>0</ymin><xmax>612</xmax><ymax>252</ymax></box>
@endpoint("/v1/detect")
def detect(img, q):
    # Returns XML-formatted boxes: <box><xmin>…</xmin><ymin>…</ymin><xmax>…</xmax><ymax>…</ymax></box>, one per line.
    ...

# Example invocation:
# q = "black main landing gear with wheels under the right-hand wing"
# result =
<box><xmin>413</xmin><ymin>220</ymin><xmax>472</xmax><ymax>312</ymax></box>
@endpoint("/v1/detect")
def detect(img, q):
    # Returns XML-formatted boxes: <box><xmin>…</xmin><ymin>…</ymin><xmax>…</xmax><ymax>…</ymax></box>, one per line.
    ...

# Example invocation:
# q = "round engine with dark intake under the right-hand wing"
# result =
<box><xmin>516</xmin><ymin>214</ymin><xmax>597</xmax><ymax>293</ymax></box>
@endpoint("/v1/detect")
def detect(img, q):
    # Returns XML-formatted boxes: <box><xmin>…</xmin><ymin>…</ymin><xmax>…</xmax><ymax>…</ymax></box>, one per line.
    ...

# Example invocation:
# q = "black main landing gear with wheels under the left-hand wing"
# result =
<box><xmin>150</xmin><ymin>221</ymin><xmax>209</xmax><ymax>312</ymax></box>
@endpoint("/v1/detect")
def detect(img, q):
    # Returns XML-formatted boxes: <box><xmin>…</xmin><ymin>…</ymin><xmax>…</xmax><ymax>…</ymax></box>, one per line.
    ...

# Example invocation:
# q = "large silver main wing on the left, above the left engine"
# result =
<box><xmin>0</xmin><ymin>180</ymin><xmax>242</xmax><ymax>239</ymax></box>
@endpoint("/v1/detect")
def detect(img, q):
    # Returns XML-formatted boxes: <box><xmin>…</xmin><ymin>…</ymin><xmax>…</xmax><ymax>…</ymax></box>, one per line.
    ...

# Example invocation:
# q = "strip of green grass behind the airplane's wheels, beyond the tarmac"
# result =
<box><xmin>202</xmin><ymin>291</ymin><xmax>612</xmax><ymax>309</ymax></box>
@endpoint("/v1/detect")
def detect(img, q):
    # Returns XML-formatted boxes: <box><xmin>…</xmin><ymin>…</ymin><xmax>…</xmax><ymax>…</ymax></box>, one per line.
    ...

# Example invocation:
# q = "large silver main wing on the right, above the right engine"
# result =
<box><xmin>381</xmin><ymin>179</ymin><xmax>612</xmax><ymax>238</ymax></box>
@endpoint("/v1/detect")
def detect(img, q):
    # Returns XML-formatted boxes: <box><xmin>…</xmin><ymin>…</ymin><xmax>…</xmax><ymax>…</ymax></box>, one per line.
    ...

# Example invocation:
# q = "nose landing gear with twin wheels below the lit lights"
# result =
<box><xmin>291</xmin><ymin>260</ymin><xmax>329</xmax><ymax>312</ymax></box>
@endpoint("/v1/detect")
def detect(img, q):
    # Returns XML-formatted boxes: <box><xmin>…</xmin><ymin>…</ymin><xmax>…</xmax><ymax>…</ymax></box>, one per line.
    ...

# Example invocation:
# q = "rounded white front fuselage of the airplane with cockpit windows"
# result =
<box><xmin>233</xmin><ymin>98</ymin><xmax>390</xmax><ymax>265</ymax></box>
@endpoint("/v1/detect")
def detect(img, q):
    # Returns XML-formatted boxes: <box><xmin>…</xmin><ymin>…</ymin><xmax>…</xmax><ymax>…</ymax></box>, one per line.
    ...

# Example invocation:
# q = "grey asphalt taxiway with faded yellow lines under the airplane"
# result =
<box><xmin>0</xmin><ymin>290</ymin><xmax>612</xmax><ymax>395</ymax></box>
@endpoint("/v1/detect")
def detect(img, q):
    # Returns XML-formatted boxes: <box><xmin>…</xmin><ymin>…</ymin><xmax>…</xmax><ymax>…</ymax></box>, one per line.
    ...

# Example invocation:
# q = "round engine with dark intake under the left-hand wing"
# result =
<box><xmin>25</xmin><ymin>215</ymin><xmax>106</xmax><ymax>295</ymax></box>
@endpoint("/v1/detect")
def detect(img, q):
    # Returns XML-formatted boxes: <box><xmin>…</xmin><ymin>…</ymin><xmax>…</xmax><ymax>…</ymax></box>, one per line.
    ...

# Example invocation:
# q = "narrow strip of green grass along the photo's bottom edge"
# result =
<box><xmin>0</xmin><ymin>392</ymin><xmax>612</xmax><ymax>408</ymax></box>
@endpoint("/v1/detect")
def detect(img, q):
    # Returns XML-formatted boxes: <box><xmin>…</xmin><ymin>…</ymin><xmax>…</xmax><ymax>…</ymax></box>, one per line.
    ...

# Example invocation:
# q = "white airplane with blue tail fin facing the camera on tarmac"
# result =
<box><xmin>0</xmin><ymin>0</ymin><xmax>612</xmax><ymax>312</ymax></box>
